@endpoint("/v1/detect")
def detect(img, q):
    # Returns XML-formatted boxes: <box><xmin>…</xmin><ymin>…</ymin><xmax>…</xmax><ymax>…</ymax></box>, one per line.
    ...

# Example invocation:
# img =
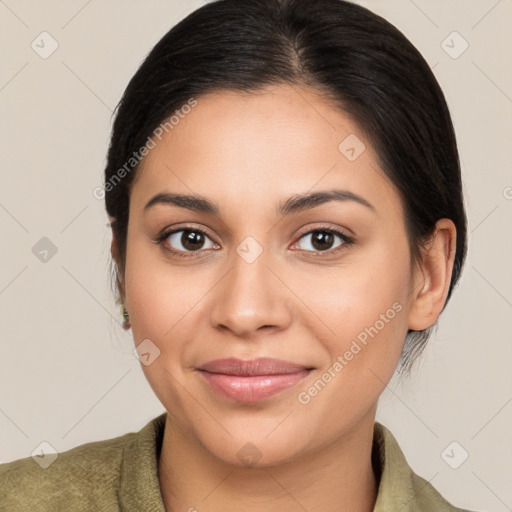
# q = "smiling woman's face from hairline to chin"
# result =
<box><xmin>124</xmin><ymin>85</ymin><xmax>415</xmax><ymax>465</ymax></box>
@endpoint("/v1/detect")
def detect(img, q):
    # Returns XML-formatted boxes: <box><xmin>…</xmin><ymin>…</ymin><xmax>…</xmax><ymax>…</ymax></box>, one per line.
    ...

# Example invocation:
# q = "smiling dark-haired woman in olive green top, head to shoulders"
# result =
<box><xmin>0</xmin><ymin>0</ymin><xmax>476</xmax><ymax>512</ymax></box>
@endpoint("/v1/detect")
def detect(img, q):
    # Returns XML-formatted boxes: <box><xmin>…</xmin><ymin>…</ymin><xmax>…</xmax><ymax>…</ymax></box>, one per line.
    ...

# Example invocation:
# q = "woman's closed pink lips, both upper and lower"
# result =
<box><xmin>198</xmin><ymin>358</ymin><xmax>312</xmax><ymax>403</ymax></box>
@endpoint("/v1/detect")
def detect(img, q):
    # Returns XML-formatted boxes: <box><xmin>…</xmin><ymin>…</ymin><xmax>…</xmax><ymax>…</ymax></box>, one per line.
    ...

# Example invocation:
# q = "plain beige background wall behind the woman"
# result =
<box><xmin>0</xmin><ymin>0</ymin><xmax>512</xmax><ymax>512</ymax></box>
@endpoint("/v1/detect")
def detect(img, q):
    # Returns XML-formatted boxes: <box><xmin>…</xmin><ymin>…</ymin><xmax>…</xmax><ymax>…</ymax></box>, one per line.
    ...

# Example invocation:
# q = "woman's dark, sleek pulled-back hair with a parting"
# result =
<box><xmin>105</xmin><ymin>0</ymin><xmax>467</xmax><ymax>373</ymax></box>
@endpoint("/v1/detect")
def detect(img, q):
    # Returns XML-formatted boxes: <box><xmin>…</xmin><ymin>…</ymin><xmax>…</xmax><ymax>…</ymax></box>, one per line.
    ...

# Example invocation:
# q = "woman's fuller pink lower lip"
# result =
<box><xmin>200</xmin><ymin>370</ymin><xmax>311</xmax><ymax>403</ymax></box>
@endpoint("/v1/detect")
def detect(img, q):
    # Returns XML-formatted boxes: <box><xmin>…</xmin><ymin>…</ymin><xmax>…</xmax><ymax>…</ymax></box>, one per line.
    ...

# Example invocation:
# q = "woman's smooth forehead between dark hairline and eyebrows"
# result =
<box><xmin>130</xmin><ymin>85</ymin><xmax>398</xmax><ymax>218</ymax></box>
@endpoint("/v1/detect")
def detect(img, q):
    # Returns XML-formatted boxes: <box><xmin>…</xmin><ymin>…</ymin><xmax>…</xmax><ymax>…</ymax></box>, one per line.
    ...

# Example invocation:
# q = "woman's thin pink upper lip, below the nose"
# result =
<box><xmin>199</xmin><ymin>357</ymin><xmax>311</xmax><ymax>375</ymax></box>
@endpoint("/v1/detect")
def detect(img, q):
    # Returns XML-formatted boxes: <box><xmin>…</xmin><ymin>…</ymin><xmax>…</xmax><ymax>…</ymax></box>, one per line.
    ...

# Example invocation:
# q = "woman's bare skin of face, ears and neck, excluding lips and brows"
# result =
<box><xmin>112</xmin><ymin>85</ymin><xmax>456</xmax><ymax>512</ymax></box>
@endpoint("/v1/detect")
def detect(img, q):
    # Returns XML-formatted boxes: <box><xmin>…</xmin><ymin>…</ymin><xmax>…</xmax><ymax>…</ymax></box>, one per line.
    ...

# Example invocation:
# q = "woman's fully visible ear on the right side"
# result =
<box><xmin>409</xmin><ymin>219</ymin><xmax>457</xmax><ymax>331</ymax></box>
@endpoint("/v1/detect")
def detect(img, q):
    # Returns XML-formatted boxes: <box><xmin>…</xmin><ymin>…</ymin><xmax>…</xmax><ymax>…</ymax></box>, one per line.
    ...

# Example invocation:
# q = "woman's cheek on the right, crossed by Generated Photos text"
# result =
<box><xmin>292</xmin><ymin>247</ymin><xmax>409</xmax><ymax>432</ymax></box>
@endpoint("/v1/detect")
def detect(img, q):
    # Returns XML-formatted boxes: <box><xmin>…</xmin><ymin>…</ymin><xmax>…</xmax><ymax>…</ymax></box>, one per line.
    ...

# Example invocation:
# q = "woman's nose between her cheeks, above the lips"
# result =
<box><xmin>210</xmin><ymin>251</ymin><xmax>293</xmax><ymax>338</ymax></box>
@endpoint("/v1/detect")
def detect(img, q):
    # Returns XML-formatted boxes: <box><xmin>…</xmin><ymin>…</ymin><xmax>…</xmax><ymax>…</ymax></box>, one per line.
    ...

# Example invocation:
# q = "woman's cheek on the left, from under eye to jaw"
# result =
<box><xmin>126</xmin><ymin>244</ymin><xmax>205</xmax><ymax>422</ymax></box>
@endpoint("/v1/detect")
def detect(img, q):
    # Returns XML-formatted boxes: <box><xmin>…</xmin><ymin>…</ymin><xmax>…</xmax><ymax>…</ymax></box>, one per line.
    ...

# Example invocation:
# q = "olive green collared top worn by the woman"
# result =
<box><xmin>0</xmin><ymin>412</ymin><xmax>476</xmax><ymax>512</ymax></box>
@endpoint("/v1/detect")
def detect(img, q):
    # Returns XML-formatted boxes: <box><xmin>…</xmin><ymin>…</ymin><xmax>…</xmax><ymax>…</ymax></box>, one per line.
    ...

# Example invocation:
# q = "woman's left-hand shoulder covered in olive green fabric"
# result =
<box><xmin>0</xmin><ymin>426</ymin><xmax>138</xmax><ymax>512</ymax></box>
